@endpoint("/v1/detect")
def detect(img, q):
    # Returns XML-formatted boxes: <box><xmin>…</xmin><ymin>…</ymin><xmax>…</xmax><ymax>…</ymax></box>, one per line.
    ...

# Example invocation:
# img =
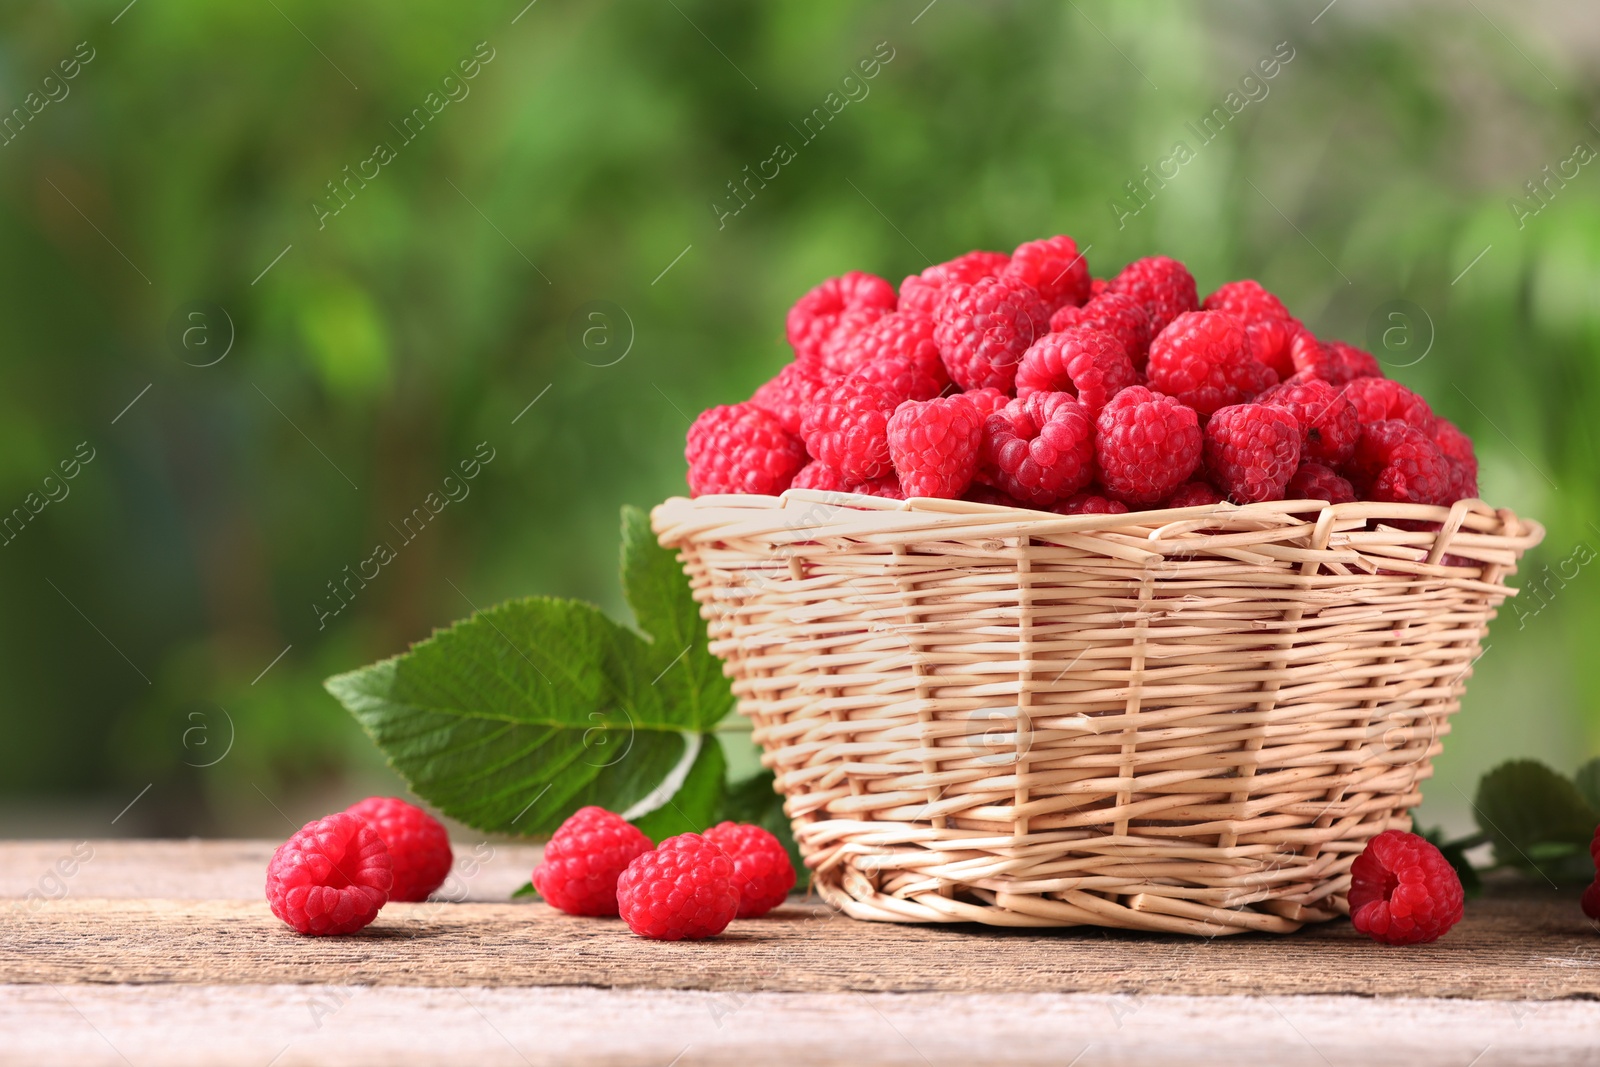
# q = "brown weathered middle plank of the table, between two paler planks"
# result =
<box><xmin>12</xmin><ymin>889</ymin><xmax>1600</xmax><ymax>1000</ymax></box>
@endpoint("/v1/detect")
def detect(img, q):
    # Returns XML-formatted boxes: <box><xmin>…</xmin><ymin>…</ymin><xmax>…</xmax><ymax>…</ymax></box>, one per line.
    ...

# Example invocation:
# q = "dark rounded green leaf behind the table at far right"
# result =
<box><xmin>1474</xmin><ymin>760</ymin><xmax>1600</xmax><ymax>877</ymax></box>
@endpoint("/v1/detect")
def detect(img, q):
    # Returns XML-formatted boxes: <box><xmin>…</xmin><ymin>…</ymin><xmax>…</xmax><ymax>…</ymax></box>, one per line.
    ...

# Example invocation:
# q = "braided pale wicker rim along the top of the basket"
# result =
<box><xmin>651</xmin><ymin>490</ymin><xmax>1546</xmax><ymax>563</ymax></box>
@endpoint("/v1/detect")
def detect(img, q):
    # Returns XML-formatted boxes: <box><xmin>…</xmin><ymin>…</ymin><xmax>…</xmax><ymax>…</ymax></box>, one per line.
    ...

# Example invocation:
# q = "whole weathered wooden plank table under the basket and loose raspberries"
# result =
<box><xmin>0</xmin><ymin>841</ymin><xmax>1600</xmax><ymax>1067</ymax></box>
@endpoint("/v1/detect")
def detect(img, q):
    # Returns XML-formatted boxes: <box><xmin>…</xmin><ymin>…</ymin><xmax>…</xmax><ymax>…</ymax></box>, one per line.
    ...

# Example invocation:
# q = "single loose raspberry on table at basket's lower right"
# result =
<box><xmin>1349</xmin><ymin>830</ymin><xmax>1466</xmax><ymax>945</ymax></box>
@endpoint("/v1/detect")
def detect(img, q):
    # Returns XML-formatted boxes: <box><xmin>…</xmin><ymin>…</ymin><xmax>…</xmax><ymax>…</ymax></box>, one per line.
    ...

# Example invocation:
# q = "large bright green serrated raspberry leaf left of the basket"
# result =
<box><xmin>325</xmin><ymin>509</ymin><xmax>733</xmax><ymax>833</ymax></box>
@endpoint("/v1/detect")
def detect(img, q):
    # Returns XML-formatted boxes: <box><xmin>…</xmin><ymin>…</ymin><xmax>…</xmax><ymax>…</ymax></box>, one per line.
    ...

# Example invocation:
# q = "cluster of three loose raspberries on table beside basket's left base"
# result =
<box><xmin>533</xmin><ymin>806</ymin><xmax>795</xmax><ymax>941</ymax></box>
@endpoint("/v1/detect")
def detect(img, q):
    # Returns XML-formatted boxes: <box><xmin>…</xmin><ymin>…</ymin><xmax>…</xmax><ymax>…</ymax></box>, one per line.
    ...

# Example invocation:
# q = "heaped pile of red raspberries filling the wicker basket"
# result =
<box><xmin>685</xmin><ymin>237</ymin><xmax>1478</xmax><ymax>515</ymax></box>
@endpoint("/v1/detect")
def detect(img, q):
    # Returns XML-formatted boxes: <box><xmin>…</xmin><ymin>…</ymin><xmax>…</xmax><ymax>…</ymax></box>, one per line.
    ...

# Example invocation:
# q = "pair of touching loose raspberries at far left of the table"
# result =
<box><xmin>267</xmin><ymin>797</ymin><xmax>454</xmax><ymax>934</ymax></box>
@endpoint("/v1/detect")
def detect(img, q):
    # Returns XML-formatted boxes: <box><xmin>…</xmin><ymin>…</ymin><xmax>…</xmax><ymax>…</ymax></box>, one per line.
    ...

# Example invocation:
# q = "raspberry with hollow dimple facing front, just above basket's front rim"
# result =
<box><xmin>984</xmin><ymin>392</ymin><xmax>1094</xmax><ymax>506</ymax></box>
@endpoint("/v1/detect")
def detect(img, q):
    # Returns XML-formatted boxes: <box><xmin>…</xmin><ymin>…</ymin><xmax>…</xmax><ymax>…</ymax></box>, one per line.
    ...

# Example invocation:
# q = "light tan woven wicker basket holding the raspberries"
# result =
<box><xmin>653</xmin><ymin>490</ymin><xmax>1544</xmax><ymax>936</ymax></box>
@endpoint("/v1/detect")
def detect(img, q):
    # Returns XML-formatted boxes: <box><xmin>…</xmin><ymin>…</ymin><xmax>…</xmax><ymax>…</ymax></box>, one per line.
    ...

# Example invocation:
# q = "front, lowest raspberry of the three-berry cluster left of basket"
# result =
<box><xmin>616</xmin><ymin>833</ymin><xmax>739</xmax><ymax>941</ymax></box>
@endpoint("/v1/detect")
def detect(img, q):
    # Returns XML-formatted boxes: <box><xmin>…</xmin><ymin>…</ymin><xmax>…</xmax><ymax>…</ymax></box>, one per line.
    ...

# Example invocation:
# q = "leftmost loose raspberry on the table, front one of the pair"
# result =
<box><xmin>267</xmin><ymin>811</ymin><xmax>394</xmax><ymax>934</ymax></box>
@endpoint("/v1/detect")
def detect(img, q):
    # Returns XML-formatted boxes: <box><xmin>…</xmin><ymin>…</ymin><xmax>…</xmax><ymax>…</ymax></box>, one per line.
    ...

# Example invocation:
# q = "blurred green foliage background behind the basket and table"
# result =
<box><xmin>0</xmin><ymin>0</ymin><xmax>1600</xmax><ymax>835</ymax></box>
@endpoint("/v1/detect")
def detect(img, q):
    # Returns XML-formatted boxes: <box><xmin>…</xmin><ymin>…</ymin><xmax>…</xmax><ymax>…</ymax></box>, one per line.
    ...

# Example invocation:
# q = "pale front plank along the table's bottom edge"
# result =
<box><xmin>0</xmin><ymin>985</ymin><xmax>1600</xmax><ymax>1067</ymax></box>
